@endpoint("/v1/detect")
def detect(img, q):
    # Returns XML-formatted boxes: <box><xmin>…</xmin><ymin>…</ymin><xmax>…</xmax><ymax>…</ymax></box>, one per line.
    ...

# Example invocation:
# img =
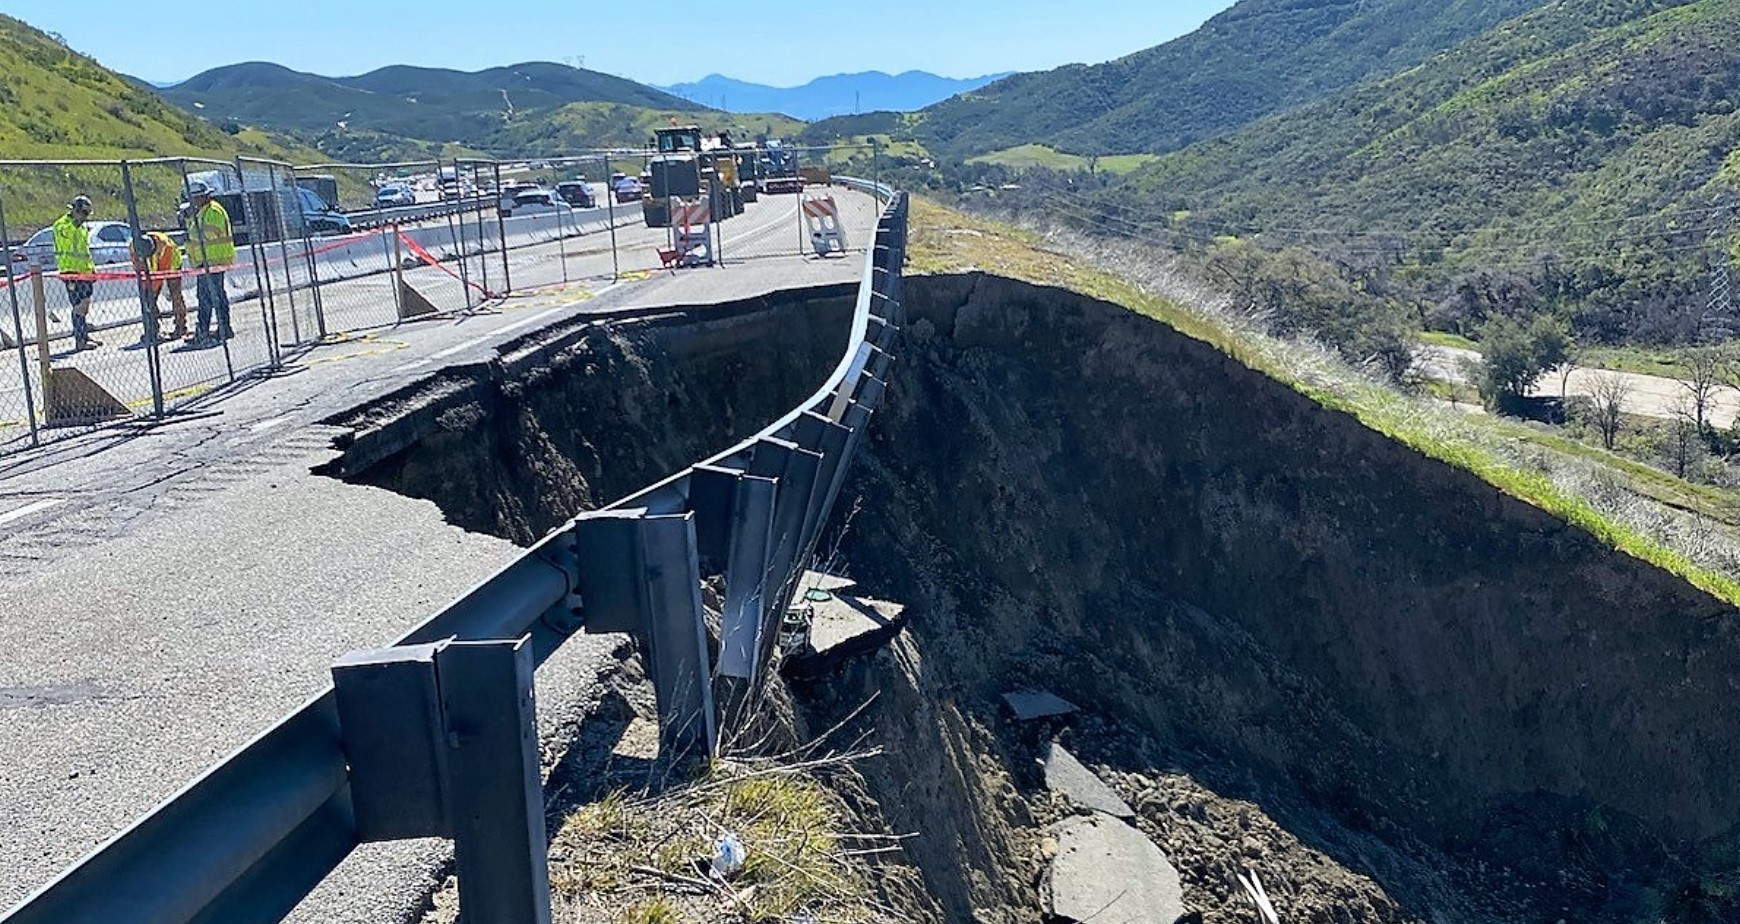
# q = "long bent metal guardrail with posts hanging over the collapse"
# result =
<box><xmin>0</xmin><ymin>181</ymin><xmax>907</xmax><ymax>924</ymax></box>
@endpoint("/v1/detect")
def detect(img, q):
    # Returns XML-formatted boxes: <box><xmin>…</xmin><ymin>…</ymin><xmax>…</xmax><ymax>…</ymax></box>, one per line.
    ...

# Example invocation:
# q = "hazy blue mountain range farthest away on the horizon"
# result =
<box><xmin>659</xmin><ymin>71</ymin><xmax>1007</xmax><ymax>122</ymax></box>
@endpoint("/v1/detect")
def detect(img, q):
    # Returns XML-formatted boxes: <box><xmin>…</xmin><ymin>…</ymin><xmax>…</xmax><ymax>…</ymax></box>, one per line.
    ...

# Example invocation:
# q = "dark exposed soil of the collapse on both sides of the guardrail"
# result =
<box><xmin>328</xmin><ymin>275</ymin><xmax>1740</xmax><ymax>924</ymax></box>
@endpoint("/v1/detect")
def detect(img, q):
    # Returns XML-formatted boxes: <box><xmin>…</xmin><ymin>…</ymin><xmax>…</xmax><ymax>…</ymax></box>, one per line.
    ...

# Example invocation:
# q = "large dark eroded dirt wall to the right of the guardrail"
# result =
<box><xmin>828</xmin><ymin>275</ymin><xmax>1740</xmax><ymax>922</ymax></box>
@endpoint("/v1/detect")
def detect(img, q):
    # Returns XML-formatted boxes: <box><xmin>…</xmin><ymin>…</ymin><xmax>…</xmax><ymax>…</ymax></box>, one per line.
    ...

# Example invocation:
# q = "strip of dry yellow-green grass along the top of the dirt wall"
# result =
<box><xmin>908</xmin><ymin>198</ymin><xmax>1740</xmax><ymax>606</ymax></box>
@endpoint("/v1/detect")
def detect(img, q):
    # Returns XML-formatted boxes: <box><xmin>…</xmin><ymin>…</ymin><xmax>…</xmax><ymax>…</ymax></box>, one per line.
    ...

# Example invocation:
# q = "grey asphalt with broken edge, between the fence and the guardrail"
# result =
<box><xmin>0</xmin><ymin>191</ymin><xmax>875</xmax><ymax>924</ymax></box>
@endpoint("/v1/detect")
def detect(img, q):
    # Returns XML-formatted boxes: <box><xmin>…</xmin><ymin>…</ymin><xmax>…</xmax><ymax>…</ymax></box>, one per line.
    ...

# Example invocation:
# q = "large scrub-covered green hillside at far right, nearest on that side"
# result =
<box><xmin>1089</xmin><ymin>0</ymin><xmax>1740</xmax><ymax>341</ymax></box>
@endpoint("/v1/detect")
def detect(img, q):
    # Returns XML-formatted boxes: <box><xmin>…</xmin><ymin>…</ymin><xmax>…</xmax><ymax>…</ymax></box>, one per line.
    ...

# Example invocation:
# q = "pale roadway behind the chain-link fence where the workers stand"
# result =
<box><xmin>0</xmin><ymin>188</ymin><xmax>875</xmax><ymax>454</ymax></box>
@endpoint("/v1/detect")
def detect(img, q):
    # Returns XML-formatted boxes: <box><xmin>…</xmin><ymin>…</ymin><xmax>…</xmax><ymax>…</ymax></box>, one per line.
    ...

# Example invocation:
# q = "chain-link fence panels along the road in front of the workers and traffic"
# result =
<box><xmin>0</xmin><ymin>145</ymin><xmax>877</xmax><ymax>454</ymax></box>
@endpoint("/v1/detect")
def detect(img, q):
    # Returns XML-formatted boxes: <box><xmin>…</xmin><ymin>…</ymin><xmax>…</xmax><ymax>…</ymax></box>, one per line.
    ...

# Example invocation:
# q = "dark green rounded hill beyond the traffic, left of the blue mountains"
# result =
<box><xmin>164</xmin><ymin>63</ymin><xmax>706</xmax><ymax>158</ymax></box>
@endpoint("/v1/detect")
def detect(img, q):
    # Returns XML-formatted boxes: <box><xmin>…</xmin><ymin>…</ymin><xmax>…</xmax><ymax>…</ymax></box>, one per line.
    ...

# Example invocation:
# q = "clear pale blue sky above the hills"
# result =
<box><xmin>0</xmin><ymin>0</ymin><xmax>1232</xmax><ymax>85</ymax></box>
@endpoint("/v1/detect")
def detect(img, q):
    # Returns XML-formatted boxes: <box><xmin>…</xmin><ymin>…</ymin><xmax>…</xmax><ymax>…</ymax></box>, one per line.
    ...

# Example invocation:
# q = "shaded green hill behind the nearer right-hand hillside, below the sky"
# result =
<box><xmin>919</xmin><ymin>0</ymin><xmax>1542</xmax><ymax>160</ymax></box>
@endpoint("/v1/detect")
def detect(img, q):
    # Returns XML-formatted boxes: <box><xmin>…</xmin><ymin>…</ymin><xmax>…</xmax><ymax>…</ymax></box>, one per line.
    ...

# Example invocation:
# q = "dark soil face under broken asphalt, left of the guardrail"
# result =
<box><xmin>331</xmin><ymin>285</ymin><xmax>856</xmax><ymax>545</ymax></box>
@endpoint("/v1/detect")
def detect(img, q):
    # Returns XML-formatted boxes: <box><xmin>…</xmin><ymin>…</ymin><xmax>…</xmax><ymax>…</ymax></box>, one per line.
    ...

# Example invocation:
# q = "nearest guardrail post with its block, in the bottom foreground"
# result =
<box><xmin>332</xmin><ymin>637</ymin><xmax>550</xmax><ymax>924</ymax></box>
